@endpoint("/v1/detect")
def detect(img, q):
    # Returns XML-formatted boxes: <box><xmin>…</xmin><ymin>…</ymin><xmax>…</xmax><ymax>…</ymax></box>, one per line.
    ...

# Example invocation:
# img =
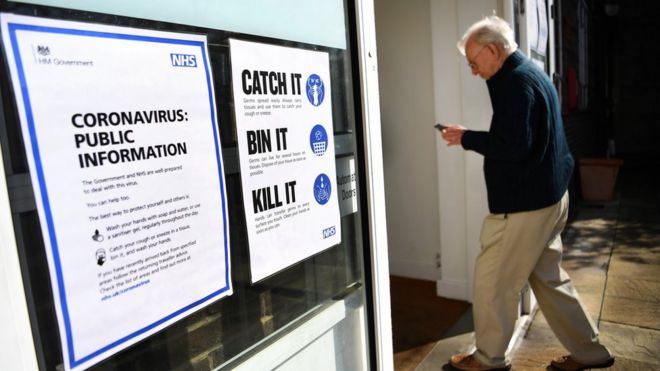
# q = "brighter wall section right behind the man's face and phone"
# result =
<box><xmin>430</xmin><ymin>0</ymin><xmax>503</xmax><ymax>301</ymax></box>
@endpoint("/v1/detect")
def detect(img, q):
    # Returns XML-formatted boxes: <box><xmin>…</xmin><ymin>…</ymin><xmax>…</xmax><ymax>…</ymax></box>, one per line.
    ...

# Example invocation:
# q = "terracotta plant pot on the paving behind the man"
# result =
<box><xmin>580</xmin><ymin>158</ymin><xmax>623</xmax><ymax>201</ymax></box>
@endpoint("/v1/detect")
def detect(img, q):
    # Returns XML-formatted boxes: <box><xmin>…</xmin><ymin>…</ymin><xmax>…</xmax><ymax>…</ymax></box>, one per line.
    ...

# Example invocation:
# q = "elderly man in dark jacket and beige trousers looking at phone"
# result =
<box><xmin>442</xmin><ymin>16</ymin><xmax>614</xmax><ymax>370</ymax></box>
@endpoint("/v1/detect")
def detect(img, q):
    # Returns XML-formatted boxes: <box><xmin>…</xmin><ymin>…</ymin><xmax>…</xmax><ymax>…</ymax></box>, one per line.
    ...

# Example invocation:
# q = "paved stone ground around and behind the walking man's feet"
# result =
<box><xmin>417</xmin><ymin>161</ymin><xmax>660</xmax><ymax>371</ymax></box>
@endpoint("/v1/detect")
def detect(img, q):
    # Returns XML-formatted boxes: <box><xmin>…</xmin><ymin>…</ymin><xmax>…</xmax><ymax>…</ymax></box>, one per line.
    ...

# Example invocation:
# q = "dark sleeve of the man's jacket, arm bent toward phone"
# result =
<box><xmin>461</xmin><ymin>80</ymin><xmax>539</xmax><ymax>162</ymax></box>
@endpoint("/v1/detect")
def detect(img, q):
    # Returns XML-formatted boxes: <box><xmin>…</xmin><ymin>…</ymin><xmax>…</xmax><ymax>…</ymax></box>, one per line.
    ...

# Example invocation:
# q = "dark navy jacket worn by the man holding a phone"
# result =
<box><xmin>461</xmin><ymin>51</ymin><xmax>574</xmax><ymax>214</ymax></box>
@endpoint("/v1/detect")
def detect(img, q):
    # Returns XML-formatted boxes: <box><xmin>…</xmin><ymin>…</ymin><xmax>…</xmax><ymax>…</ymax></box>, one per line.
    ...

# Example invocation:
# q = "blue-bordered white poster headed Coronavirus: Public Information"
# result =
<box><xmin>0</xmin><ymin>14</ymin><xmax>232</xmax><ymax>369</ymax></box>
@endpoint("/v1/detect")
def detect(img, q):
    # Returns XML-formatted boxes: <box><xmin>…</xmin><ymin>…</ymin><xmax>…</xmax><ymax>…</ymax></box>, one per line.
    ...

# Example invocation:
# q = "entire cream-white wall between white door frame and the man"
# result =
<box><xmin>375</xmin><ymin>0</ymin><xmax>512</xmax><ymax>301</ymax></box>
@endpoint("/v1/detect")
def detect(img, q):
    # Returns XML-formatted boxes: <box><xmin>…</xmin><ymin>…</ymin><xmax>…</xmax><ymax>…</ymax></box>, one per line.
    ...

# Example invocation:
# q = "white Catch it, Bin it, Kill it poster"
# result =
<box><xmin>230</xmin><ymin>40</ymin><xmax>341</xmax><ymax>282</ymax></box>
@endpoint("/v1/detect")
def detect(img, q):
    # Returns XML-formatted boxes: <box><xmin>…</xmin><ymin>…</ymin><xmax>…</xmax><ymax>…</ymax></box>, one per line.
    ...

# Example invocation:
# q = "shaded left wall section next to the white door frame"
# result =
<box><xmin>375</xmin><ymin>0</ymin><xmax>440</xmax><ymax>281</ymax></box>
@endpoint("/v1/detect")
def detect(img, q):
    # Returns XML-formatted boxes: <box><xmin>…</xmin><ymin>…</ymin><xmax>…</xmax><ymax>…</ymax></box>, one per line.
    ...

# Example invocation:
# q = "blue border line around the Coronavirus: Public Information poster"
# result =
<box><xmin>7</xmin><ymin>22</ymin><xmax>230</xmax><ymax>368</ymax></box>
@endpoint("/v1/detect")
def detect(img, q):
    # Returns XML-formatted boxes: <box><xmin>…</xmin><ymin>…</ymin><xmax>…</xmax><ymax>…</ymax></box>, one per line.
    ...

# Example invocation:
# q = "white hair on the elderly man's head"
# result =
<box><xmin>456</xmin><ymin>15</ymin><xmax>518</xmax><ymax>55</ymax></box>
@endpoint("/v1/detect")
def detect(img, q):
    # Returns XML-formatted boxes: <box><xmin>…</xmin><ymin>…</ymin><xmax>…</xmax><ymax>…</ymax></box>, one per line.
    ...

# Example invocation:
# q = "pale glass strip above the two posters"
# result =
<box><xmin>9</xmin><ymin>0</ymin><xmax>346</xmax><ymax>49</ymax></box>
